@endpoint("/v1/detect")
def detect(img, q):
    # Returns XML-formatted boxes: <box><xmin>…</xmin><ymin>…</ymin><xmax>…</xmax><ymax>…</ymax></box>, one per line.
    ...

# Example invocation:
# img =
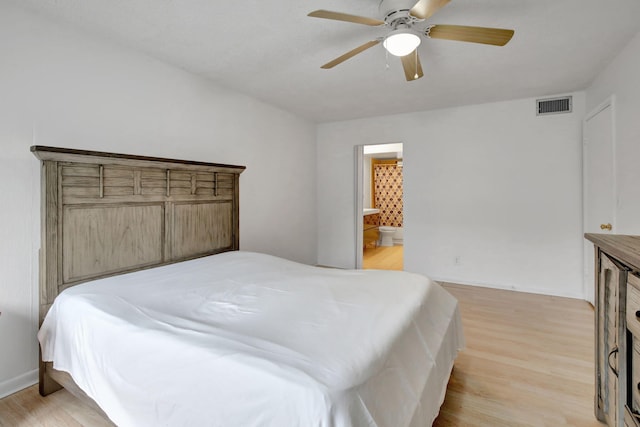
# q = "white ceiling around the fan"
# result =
<box><xmin>14</xmin><ymin>0</ymin><xmax>640</xmax><ymax>122</ymax></box>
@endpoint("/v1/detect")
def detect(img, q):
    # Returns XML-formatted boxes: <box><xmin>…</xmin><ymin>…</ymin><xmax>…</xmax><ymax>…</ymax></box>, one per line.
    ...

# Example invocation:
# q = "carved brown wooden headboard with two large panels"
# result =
<box><xmin>31</xmin><ymin>146</ymin><xmax>245</xmax><ymax>323</ymax></box>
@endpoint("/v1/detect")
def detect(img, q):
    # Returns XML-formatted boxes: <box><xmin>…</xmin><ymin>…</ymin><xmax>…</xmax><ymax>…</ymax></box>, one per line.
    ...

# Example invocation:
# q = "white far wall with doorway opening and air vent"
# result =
<box><xmin>317</xmin><ymin>92</ymin><xmax>585</xmax><ymax>297</ymax></box>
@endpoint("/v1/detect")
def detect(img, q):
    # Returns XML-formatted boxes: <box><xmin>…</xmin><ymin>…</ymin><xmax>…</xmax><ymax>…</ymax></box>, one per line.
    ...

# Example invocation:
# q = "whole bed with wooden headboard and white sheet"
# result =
<box><xmin>32</xmin><ymin>147</ymin><xmax>464</xmax><ymax>427</ymax></box>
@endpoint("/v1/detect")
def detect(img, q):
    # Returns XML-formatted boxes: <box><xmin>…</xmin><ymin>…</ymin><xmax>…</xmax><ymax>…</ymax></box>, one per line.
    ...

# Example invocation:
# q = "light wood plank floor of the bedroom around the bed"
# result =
<box><xmin>0</xmin><ymin>284</ymin><xmax>602</xmax><ymax>427</ymax></box>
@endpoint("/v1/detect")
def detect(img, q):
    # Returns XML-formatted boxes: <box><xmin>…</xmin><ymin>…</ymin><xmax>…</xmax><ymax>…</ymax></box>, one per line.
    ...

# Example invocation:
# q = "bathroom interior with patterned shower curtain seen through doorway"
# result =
<box><xmin>362</xmin><ymin>143</ymin><xmax>403</xmax><ymax>270</ymax></box>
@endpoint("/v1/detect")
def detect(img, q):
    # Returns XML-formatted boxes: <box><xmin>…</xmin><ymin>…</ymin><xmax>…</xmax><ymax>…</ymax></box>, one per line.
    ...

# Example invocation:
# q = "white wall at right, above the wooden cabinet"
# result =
<box><xmin>587</xmin><ymin>33</ymin><xmax>640</xmax><ymax>234</ymax></box>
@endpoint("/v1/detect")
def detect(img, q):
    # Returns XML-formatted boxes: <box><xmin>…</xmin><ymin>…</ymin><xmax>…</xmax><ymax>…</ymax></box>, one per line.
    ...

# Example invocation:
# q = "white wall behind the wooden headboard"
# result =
<box><xmin>0</xmin><ymin>2</ymin><xmax>316</xmax><ymax>396</ymax></box>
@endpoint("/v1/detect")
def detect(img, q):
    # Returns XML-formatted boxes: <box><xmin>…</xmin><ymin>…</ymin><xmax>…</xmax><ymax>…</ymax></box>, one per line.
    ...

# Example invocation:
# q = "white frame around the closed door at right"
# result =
<box><xmin>582</xmin><ymin>95</ymin><xmax>618</xmax><ymax>304</ymax></box>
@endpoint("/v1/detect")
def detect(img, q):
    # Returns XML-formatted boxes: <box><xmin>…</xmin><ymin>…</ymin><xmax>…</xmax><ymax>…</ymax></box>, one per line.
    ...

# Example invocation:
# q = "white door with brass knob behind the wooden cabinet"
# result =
<box><xmin>583</xmin><ymin>98</ymin><xmax>616</xmax><ymax>304</ymax></box>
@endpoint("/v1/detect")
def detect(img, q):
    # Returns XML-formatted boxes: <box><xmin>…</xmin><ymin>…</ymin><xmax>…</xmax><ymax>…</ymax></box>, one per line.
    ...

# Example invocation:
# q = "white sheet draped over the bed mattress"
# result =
<box><xmin>38</xmin><ymin>252</ymin><xmax>464</xmax><ymax>427</ymax></box>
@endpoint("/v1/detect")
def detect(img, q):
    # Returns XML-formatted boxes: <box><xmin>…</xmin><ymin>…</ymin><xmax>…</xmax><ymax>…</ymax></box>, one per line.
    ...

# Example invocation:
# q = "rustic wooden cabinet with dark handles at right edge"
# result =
<box><xmin>585</xmin><ymin>234</ymin><xmax>640</xmax><ymax>427</ymax></box>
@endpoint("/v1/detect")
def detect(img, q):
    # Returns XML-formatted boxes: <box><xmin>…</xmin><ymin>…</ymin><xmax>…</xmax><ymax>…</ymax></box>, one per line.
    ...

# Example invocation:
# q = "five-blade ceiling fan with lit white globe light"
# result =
<box><xmin>308</xmin><ymin>0</ymin><xmax>514</xmax><ymax>81</ymax></box>
